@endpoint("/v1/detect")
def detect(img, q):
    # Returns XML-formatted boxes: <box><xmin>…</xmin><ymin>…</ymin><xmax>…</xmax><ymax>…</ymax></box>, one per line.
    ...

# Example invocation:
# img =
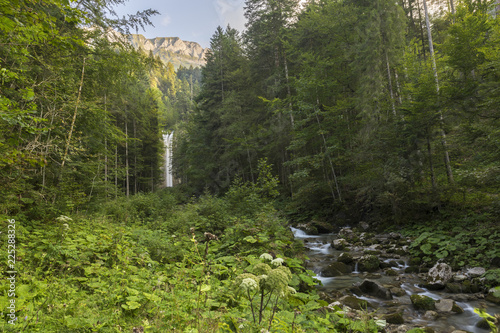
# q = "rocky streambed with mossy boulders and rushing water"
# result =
<box><xmin>292</xmin><ymin>223</ymin><xmax>500</xmax><ymax>333</ymax></box>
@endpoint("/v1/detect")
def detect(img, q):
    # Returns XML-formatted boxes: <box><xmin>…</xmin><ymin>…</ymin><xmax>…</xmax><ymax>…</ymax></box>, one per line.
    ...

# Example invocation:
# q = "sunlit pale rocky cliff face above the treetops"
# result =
<box><xmin>128</xmin><ymin>34</ymin><xmax>208</xmax><ymax>69</ymax></box>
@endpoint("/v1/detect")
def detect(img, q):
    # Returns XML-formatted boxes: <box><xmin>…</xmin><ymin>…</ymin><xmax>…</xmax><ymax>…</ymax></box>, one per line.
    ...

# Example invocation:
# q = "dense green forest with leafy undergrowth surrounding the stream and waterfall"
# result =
<box><xmin>0</xmin><ymin>0</ymin><xmax>500</xmax><ymax>333</ymax></box>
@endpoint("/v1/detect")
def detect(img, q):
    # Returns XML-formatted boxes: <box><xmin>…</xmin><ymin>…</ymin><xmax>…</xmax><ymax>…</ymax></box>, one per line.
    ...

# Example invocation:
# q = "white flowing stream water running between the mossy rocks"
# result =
<box><xmin>291</xmin><ymin>228</ymin><xmax>500</xmax><ymax>333</ymax></box>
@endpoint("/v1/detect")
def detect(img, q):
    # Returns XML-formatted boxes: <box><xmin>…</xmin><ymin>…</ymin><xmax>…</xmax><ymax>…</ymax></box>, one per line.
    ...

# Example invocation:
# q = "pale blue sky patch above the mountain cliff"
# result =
<box><xmin>115</xmin><ymin>0</ymin><xmax>245</xmax><ymax>47</ymax></box>
